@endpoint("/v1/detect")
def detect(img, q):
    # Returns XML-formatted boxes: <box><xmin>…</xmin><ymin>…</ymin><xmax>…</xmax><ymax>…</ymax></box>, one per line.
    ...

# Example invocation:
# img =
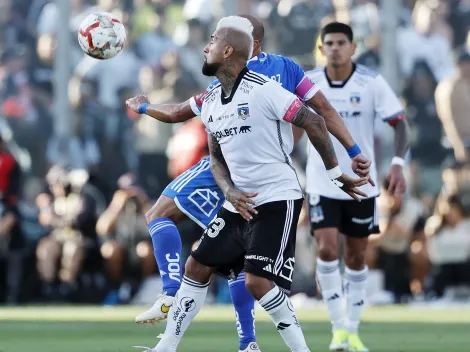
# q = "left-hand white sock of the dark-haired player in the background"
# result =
<box><xmin>316</xmin><ymin>258</ymin><xmax>346</xmax><ymax>332</ymax></box>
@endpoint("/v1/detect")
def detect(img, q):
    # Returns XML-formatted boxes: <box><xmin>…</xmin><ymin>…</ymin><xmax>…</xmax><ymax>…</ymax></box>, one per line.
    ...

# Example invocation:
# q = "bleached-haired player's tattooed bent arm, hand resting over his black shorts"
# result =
<box><xmin>209</xmin><ymin>136</ymin><xmax>258</xmax><ymax>221</ymax></box>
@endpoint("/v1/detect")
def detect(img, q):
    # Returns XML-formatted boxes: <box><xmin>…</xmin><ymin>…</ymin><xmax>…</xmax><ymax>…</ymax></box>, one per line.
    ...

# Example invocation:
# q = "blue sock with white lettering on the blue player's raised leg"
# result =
<box><xmin>148</xmin><ymin>218</ymin><xmax>182</xmax><ymax>296</ymax></box>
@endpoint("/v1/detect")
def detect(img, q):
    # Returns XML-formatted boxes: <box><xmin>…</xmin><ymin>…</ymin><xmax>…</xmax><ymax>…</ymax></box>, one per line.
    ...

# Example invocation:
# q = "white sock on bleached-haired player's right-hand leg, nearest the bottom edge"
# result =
<box><xmin>259</xmin><ymin>286</ymin><xmax>310</xmax><ymax>352</ymax></box>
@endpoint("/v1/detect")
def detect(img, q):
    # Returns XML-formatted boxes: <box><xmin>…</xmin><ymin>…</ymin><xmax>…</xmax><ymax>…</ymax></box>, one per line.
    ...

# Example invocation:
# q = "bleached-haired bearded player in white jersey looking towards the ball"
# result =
<box><xmin>152</xmin><ymin>16</ymin><xmax>368</xmax><ymax>352</ymax></box>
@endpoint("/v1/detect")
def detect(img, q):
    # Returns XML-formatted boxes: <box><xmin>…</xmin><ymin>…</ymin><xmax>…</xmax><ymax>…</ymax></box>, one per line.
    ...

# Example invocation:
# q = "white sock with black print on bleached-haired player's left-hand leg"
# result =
<box><xmin>155</xmin><ymin>276</ymin><xmax>210</xmax><ymax>352</ymax></box>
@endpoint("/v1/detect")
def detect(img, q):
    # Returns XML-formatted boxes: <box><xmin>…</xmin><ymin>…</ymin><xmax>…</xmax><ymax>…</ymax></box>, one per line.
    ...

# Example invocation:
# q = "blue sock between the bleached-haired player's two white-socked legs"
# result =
<box><xmin>228</xmin><ymin>273</ymin><xmax>256</xmax><ymax>350</ymax></box>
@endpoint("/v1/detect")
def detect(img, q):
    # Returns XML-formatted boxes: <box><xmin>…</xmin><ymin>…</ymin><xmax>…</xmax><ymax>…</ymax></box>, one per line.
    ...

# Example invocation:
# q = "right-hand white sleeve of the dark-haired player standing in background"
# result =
<box><xmin>374</xmin><ymin>75</ymin><xmax>405</xmax><ymax>126</ymax></box>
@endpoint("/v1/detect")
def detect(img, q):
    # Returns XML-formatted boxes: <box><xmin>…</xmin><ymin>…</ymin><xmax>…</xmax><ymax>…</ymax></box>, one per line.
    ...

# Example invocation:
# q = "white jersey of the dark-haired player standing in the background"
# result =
<box><xmin>306</xmin><ymin>65</ymin><xmax>404</xmax><ymax>200</ymax></box>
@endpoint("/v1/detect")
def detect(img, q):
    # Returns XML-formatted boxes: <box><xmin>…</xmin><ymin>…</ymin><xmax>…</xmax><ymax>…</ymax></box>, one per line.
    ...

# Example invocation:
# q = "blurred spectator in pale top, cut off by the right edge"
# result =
<box><xmin>435</xmin><ymin>51</ymin><xmax>470</xmax><ymax>161</ymax></box>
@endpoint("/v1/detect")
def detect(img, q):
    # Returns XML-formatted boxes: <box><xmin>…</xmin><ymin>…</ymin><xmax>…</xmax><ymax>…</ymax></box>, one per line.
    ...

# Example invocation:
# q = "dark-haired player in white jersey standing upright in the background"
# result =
<box><xmin>307</xmin><ymin>22</ymin><xmax>409</xmax><ymax>352</ymax></box>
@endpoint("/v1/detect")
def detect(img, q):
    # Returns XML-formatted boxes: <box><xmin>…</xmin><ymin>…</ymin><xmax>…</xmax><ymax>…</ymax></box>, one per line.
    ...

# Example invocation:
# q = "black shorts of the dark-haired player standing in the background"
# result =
<box><xmin>309</xmin><ymin>195</ymin><xmax>379</xmax><ymax>237</ymax></box>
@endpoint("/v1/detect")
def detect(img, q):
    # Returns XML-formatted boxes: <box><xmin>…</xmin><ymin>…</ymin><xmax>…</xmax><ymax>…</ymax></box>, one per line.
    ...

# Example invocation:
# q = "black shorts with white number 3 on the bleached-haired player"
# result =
<box><xmin>191</xmin><ymin>199</ymin><xmax>303</xmax><ymax>292</ymax></box>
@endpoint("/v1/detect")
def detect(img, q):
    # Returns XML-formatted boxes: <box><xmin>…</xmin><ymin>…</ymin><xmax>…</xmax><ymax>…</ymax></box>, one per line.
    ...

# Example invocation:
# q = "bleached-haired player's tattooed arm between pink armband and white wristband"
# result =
<box><xmin>292</xmin><ymin>106</ymin><xmax>338</xmax><ymax>170</ymax></box>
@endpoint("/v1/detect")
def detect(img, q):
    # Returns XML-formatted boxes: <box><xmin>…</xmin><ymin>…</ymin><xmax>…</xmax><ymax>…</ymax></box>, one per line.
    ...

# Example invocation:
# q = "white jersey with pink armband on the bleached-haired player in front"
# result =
<box><xmin>201</xmin><ymin>68</ymin><xmax>302</xmax><ymax>211</ymax></box>
